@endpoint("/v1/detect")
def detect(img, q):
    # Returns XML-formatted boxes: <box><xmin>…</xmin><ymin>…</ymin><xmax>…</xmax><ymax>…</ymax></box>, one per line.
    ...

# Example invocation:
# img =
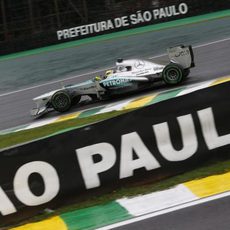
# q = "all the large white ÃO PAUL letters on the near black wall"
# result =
<box><xmin>0</xmin><ymin>107</ymin><xmax>230</xmax><ymax>216</ymax></box>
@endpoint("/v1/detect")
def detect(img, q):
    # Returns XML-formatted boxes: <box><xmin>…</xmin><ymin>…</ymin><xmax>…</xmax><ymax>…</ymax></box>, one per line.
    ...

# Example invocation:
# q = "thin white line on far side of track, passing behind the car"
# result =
<box><xmin>0</xmin><ymin>38</ymin><xmax>230</xmax><ymax>97</ymax></box>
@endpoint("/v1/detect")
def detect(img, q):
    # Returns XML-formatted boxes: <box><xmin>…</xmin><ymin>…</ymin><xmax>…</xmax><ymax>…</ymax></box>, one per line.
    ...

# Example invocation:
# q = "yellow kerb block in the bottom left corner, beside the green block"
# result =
<box><xmin>11</xmin><ymin>216</ymin><xmax>68</xmax><ymax>230</ymax></box>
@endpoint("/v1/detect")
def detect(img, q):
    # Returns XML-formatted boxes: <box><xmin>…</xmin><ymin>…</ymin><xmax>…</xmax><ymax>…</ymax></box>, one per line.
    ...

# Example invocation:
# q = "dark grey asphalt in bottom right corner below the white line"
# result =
<box><xmin>113</xmin><ymin>196</ymin><xmax>230</xmax><ymax>230</ymax></box>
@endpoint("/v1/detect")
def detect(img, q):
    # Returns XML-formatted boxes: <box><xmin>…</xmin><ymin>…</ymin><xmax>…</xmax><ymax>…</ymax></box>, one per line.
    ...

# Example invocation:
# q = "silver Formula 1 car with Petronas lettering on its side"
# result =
<box><xmin>31</xmin><ymin>45</ymin><xmax>195</xmax><ymax>117</ymax></box>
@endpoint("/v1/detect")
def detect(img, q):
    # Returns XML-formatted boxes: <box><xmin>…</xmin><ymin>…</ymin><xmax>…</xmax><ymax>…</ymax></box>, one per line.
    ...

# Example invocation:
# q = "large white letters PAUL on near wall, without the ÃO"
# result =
<box><xmin>76</xmin><ymin>108</ymin><xmax>230</xmax><ymax>189</ymax></box>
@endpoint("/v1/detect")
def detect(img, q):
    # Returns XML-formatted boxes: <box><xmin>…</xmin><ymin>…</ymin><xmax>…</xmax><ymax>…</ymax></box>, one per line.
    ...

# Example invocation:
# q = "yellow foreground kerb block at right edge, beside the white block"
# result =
<box><xmin>184</xmin><ymin>172</ymin><xmax>230</xmax><ymax>198</ymax></box>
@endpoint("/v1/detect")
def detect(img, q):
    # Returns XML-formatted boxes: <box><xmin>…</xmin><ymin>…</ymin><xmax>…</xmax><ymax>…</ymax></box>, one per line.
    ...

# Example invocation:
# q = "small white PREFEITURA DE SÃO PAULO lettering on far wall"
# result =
<box><xmin>57</xmin><ymin>3</ymin><xmax>189</xmax><ymax>40</ymax></box>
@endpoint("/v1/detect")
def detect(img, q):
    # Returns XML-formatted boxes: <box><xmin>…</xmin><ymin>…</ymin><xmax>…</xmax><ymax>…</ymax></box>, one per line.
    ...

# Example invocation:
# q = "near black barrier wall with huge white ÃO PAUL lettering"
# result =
<box><xmin>0</xmin><ymin>82</ymin><xmax>230</xmax><ymax>225</ymax></box>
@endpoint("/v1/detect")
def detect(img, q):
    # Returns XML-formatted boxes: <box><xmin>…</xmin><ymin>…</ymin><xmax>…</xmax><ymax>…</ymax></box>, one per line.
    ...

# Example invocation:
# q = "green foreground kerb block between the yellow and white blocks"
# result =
<box><xmin>60</xmin><ymin>201</ymin><xmax>132</xmax><ymax>230</ymax></box>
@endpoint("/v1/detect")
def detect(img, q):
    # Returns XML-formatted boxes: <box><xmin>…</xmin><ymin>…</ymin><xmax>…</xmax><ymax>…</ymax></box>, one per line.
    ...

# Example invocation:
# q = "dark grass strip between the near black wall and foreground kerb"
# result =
<box><xmin>10</xmin><ymin>155</ymin><xmax>230</xmax><ymax>228</ymax></box>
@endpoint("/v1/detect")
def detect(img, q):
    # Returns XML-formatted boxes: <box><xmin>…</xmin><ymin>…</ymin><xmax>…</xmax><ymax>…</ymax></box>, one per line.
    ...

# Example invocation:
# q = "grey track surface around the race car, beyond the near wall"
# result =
<box><xmin>0</xmin><ymin>17</ymin><xmax>230</xmax><ymax>130</ymax></box>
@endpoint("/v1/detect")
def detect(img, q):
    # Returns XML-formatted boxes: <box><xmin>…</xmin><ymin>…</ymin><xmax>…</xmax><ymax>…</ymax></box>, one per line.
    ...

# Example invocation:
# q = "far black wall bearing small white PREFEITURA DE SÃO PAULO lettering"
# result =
<box><xmin>0</xmin><ymin>0</ymin><xmax>230</xmax><ymax>55</ymax></box>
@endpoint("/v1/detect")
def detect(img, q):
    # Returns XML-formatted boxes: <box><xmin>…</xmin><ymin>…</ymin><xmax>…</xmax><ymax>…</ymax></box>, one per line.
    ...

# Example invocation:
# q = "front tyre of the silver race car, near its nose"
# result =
<box><xmin>51</xmin><ymin>91</ymin><xmax>72</xmax><ymax>113</ymax></box>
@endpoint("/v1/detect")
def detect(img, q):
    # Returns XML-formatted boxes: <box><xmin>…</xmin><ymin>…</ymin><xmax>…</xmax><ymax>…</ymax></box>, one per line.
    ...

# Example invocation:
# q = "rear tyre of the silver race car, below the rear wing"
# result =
<box><xmin>162</xmin><ymin>63</ymin><xmax>184</xmax><ymax>85</ymax></box>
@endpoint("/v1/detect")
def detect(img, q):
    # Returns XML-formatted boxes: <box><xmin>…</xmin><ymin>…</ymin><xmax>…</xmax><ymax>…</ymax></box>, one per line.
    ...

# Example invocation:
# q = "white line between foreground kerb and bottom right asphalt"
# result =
<box><xmin>97</xmin><ymin>192</ymin><xmax>230</xmax><ymax>230</ymax></box>
